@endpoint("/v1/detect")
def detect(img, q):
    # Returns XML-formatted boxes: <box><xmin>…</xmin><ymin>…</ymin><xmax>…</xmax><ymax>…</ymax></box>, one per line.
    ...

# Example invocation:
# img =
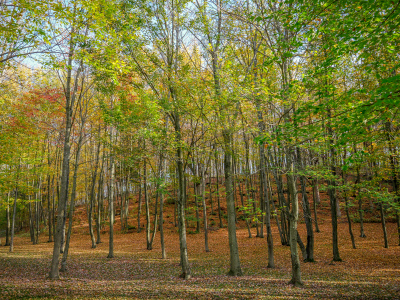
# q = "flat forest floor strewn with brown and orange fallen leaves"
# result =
<box><xmin>0</xmin><ymin>191</ymin><xmax>400</xmax><ymax>299</ymax></box>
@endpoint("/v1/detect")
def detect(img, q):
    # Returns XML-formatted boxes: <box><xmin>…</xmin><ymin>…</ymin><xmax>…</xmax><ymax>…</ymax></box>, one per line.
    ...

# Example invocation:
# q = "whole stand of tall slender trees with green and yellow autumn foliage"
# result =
<box><xmin>0</xmin><ymin>0</ymin><xmax>400</xmax><ymax>285</ymax></box>
